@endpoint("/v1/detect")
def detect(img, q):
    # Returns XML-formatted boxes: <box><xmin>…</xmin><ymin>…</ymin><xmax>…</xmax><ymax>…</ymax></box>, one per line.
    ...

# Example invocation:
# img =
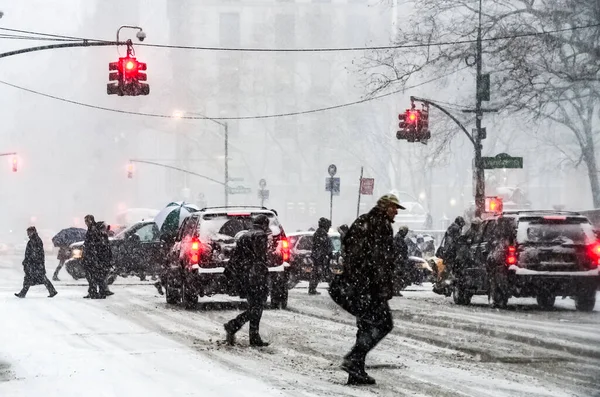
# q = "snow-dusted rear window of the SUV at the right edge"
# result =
<box><xmin>517</xmin><ymin>219</ymin><xmax>596</xmax><ymax>244</ymax></box>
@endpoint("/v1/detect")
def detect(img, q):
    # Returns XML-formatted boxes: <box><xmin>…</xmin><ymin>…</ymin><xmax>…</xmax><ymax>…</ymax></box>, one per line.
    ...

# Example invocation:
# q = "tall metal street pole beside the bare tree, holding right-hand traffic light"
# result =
<box><xmin>474</xmin><ymin>0</ymin><xmax>485</xmax><ymax>217</ymax></box>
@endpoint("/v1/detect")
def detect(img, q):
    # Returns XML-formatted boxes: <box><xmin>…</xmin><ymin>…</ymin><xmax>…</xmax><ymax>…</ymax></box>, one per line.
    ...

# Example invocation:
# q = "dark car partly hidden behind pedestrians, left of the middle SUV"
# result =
<box><xmin>65</xmin><ymin>221</ymin><xmax>167</xmax><ymax>284</ymax></box>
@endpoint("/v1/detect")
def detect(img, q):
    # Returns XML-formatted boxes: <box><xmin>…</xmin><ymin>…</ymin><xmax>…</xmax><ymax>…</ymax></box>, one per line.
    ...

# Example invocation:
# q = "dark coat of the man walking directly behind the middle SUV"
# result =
<box><xmin>227</xmin><ymin>229</ymin><xmax>269</xmax><ymax>294</ymax></box>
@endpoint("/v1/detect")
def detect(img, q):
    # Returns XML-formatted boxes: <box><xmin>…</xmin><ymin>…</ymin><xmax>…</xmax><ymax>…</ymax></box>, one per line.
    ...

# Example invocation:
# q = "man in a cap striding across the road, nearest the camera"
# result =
<box><xmin>330</xmin><ymin>194</ymin><xmax>404</xmax><ymax>385</ymax></box>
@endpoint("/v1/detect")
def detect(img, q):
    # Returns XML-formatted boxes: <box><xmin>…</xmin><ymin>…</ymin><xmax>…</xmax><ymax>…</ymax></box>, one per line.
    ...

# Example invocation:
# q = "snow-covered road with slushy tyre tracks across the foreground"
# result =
<box><xmin>0</xmin><ymin>257</ymin><xmax>600</xmax><ymax>397</ymax></box>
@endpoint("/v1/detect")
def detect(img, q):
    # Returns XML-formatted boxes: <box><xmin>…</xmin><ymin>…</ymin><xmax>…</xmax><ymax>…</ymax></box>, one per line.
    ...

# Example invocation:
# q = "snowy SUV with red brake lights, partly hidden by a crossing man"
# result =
<box><xmin>161</xmin><ymin>207</ymin><xmax>290</xmax><ymax>309</ymax></box>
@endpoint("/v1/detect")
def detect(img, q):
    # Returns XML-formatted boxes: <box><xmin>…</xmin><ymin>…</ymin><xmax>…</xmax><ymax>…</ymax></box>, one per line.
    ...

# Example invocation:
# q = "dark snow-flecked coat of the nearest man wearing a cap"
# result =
<box><xmin>342</xmin><ymin>207</ymin><xmax>396</xmax><ymax>300</ymax></box>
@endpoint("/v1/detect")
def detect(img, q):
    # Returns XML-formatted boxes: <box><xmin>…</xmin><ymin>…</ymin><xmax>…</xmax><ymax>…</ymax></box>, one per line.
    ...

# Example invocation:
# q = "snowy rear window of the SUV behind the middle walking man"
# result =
<box><xmin>199</xmin><ymin>212</ymin><xmax>282</xmax><ymax>240</ymax></box>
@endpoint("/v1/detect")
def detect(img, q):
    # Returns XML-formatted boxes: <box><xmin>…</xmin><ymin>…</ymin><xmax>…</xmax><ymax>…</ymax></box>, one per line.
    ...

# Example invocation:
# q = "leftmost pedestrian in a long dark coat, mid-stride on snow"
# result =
<box><xmin>15</xmin><ymin>226</ymin><xmax>58</xmax><ymax>298</ymax></box>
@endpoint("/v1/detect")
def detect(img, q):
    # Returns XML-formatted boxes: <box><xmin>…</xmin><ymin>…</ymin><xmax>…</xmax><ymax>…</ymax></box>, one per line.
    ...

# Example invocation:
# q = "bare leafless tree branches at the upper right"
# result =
<box><xmin>364</xmin><ymin>0</ymin><xmax>600</xmax><ymax>208</ymax></box>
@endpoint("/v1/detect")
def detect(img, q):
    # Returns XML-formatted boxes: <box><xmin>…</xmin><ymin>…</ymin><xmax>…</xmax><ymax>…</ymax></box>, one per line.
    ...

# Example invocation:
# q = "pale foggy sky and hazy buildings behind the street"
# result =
<box><xmin>0</xmin><ymin>0</ymin><xmax>591</xmax><ymax>235</ymax></box>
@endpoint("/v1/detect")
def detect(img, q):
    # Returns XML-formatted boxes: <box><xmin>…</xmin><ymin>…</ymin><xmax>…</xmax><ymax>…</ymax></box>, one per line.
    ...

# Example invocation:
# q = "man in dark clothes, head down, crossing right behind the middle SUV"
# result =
<box><xmin>224</xmin><ymin>215</ymin><xmax>269</xmax><ymax>347</ymax></box>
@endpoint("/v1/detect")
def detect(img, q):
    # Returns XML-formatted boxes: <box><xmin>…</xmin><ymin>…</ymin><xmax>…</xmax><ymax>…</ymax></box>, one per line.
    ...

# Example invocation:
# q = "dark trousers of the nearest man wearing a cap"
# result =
<box><xmin>345</xmin><ymin>301</ymin><xmax>394</xmax><ymax>371</ymax></box>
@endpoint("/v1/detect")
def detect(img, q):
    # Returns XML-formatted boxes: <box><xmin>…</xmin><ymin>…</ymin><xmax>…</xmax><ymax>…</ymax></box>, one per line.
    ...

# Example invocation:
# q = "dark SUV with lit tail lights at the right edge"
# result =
<box><xmin>453</xmin><ymin>211</ymin><xmax>600</xmax><ymax>311</ymax></box>
